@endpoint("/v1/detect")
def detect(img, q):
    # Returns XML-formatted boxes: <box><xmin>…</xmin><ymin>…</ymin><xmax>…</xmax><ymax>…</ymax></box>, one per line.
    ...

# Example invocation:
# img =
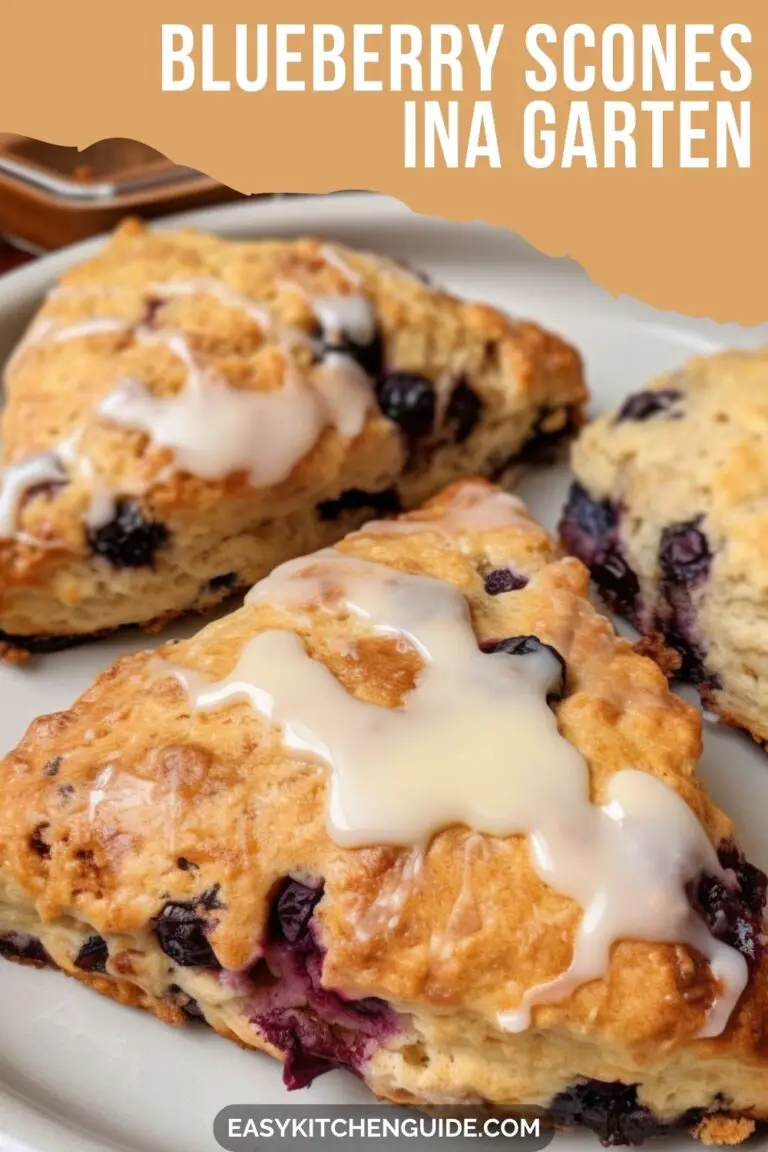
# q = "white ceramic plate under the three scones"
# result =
<box><xmin>0</xmin><ymin>194</ymin><xmax>768</xmax><ymax>1152</ymax></box>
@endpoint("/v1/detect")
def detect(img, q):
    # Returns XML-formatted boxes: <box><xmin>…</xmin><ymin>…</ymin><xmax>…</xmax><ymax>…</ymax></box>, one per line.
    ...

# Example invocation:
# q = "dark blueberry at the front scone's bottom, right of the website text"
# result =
<box><xmin>547</xmin><ymin>1079</ymin><xmax>701</xmax><ymax>1146</ymax></box>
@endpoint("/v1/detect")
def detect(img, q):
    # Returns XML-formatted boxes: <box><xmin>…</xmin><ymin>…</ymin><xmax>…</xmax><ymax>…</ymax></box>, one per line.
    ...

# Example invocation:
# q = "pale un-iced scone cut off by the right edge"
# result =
<box><xmin>561</xmin><ymin>349</ymin><xmax>768</xmax><ymax>743</ymax></box>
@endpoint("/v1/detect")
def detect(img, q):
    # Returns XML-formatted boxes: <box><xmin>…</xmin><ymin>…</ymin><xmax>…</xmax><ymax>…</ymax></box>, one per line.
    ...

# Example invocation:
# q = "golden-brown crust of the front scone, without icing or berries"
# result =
<box><xmin>0</xmin><ymin>485</ymin><xmax>768</xmax><ymax>1143</ymax></box>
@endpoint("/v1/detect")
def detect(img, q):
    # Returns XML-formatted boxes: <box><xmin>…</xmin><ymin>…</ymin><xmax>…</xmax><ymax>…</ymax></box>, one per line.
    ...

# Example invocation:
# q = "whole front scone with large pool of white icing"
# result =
<box><xmin>0</xmin><ymin>480</ymin><xmax>768</xmax><ymax>1143</ymax></box>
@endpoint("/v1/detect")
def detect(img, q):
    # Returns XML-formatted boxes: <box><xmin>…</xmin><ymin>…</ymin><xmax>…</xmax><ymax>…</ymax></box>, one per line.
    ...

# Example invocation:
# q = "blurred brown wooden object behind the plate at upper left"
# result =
<box><xmin>0</xmin><ymin>134</ymin><xmax>242</xmax><ymax>273</ymax></box>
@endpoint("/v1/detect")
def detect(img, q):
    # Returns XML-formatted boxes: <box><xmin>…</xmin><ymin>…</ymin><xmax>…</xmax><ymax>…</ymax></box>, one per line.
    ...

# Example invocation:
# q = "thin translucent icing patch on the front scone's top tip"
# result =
<box><xmin>357</xmin><ymin>483</ymin><xmax>531</xmax><ymax>536</ymax></box>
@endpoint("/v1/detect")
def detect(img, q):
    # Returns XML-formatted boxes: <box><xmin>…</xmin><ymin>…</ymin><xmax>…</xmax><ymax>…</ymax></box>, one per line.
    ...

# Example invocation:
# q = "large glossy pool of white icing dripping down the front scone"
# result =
<box><xmin>175</xmin><ymin>550</ymin><xmax>747</xmax><ymax>1036</ymax></box>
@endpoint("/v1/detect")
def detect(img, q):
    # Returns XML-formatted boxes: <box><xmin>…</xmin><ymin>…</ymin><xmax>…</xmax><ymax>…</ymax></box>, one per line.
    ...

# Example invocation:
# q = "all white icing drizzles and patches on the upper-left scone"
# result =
<box><xmin>0</xmin><ymin>261</ymin><xmax>375</xmax><ymax>539</ymax></box>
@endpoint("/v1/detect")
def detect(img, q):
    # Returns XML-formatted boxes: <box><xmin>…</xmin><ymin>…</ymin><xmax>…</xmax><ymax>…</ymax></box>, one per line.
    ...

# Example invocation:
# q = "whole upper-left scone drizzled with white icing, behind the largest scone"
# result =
<box><xmin>0</xmin><ymin>214</ymin><xmax>586</xmax><ymax>651</ymax></box>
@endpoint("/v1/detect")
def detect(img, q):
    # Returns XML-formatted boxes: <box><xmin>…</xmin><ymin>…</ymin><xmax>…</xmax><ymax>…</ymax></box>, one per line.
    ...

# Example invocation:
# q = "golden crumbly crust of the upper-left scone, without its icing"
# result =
<box><xmin>0</xmin><ymin>221</ymin><xmax>586</xmax><ymax>649</ymax></box>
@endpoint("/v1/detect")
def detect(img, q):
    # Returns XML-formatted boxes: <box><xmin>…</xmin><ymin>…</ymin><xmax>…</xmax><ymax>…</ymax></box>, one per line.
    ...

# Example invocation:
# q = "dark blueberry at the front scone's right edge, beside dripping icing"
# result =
<box><xmin>691</xmin><ymin>840</ymin><xmax>768</xmax><ymax>973</ymax></box>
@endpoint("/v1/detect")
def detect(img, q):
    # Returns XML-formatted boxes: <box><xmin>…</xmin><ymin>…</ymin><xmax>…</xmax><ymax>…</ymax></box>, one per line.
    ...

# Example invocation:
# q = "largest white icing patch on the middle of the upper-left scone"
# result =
<box><xmin>98</xmin><ymin>331</ymin><xmax>372</xmax><ymax>487</ymax></box>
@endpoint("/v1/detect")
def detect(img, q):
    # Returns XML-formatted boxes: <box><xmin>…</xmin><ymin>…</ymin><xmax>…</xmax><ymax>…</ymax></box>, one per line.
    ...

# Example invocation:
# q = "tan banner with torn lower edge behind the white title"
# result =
<box><xmin>0</xmin><ymin>0</ymin><xmax>768</xmax><ymax>324</ymax></box>
